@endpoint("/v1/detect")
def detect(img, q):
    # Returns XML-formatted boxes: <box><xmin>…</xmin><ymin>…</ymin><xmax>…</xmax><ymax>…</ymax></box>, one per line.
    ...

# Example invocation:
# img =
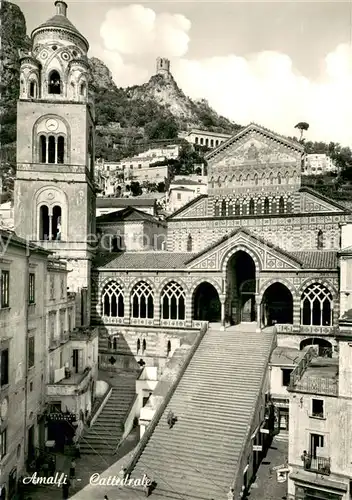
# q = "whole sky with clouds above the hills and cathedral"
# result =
<box><xmin>15</xmin><ymin>0</ymin><xmax>352</xmax><ymax>146</ymax></box>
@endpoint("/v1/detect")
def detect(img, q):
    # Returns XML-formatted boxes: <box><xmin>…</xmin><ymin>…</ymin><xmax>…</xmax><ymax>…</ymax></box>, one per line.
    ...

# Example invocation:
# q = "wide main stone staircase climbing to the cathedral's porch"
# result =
<box><xmin>131</xmin><ymin>324</ymin><xmax>274</xmax><ymax>500</ymax></box>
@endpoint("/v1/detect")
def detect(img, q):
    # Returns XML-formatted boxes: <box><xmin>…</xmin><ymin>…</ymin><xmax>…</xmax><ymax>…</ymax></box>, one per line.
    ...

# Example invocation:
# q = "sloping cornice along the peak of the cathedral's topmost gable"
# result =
<box><xmin>205</xmin><ymin>123</ymin><xmax>304</xmax><ymax>163</ymax></box>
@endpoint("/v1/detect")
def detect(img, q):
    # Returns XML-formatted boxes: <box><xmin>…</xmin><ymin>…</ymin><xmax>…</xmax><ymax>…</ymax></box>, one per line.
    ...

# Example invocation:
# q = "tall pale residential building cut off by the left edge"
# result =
<box><xmin>0</xmin><ymin>230</ymin><xmax>49</xmax><ymax>498</ymax></box>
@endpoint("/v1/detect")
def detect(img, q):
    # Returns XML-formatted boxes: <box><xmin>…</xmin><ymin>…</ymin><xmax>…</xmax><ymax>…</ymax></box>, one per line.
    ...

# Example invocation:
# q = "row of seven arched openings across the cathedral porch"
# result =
<box><xmin>99</xmin><ymin>272</ymin><xmax>334</xmax><ymax>327</ymax></box>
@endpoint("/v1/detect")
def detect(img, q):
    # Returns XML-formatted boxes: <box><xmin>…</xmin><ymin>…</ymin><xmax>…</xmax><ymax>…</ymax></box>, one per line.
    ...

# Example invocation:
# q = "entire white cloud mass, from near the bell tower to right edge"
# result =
<box><xmin>95</xmin><ymin>5</ymin><xmax>352</xmax><ymax>145</ymax></box>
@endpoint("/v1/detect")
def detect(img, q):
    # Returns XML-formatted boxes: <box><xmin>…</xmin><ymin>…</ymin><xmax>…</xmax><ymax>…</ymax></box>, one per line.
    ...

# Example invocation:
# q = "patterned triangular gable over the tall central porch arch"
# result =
<box><xmin>186</xmin><ymin>229</ymin><xmax>303</xmax><ymax>271</ymax></box>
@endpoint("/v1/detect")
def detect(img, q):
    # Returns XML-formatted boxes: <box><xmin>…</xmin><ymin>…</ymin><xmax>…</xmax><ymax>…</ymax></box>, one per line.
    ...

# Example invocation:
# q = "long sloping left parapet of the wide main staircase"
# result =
<box><xmin>125</xmin><ymin>324</ymin><xmax>208</xmax><ymax>476</ymax></box>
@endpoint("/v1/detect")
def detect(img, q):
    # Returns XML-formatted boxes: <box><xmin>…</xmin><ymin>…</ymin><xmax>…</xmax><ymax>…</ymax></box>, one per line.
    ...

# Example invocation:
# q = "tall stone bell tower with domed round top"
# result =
<box><xmin>14</xmin><ymin>0</ymin><xmax>95</xmax><ymax>321</ymax></box>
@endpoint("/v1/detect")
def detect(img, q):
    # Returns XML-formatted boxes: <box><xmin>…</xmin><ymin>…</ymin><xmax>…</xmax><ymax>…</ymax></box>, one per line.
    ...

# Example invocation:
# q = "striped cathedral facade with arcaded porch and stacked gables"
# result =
<box><xmin>92</xmin><ymin>124</ymin><xmax>352</xmax><ymax>366</ymax></box>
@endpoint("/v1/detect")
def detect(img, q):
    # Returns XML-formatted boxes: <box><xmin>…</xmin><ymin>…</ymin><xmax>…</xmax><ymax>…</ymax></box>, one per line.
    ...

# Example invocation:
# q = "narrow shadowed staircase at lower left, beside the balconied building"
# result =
<box><xmin>80</xmin><ymin>377</ymin><xmax>135</xmax><ymax>455</ymax></box>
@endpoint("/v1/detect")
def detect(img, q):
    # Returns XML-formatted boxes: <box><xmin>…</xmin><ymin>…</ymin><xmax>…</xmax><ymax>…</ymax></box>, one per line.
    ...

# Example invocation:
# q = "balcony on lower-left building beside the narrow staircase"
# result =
<box><xmin>46</xmin><ymin>367</ymin><xmax>92</xmax><ymax>397</ymax></box>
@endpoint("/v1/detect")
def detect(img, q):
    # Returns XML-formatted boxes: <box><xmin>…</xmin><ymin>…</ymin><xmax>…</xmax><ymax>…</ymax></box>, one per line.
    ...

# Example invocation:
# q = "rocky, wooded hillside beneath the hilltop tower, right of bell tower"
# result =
<box><xmin>90</xmin><ymin>57</ymin><xmax>241</xmax><ymax>160</ymax></box>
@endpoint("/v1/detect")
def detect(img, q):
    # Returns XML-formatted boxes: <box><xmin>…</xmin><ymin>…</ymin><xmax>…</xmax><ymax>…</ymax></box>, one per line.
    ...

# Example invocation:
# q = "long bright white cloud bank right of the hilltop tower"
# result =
<box><xmin>173</xmin><ymin>44</ymin><xmax>352</xmax><ymax>145</ymax></box>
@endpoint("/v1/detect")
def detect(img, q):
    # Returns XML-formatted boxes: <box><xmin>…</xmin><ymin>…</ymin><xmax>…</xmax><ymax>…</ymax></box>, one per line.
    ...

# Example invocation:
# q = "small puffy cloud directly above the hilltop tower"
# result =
<box><xmin>100</xmin><ymin>5</ymin><xmax>191</xmax><ymax>57</ymax></box>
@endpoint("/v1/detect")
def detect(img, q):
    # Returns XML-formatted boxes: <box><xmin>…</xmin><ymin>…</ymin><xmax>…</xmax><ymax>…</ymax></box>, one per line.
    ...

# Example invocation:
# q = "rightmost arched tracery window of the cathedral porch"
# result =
<box><xmin>301</xmin><ymin>283</ymin><xmax>334</xmax><ymax>326</ymax></box>
